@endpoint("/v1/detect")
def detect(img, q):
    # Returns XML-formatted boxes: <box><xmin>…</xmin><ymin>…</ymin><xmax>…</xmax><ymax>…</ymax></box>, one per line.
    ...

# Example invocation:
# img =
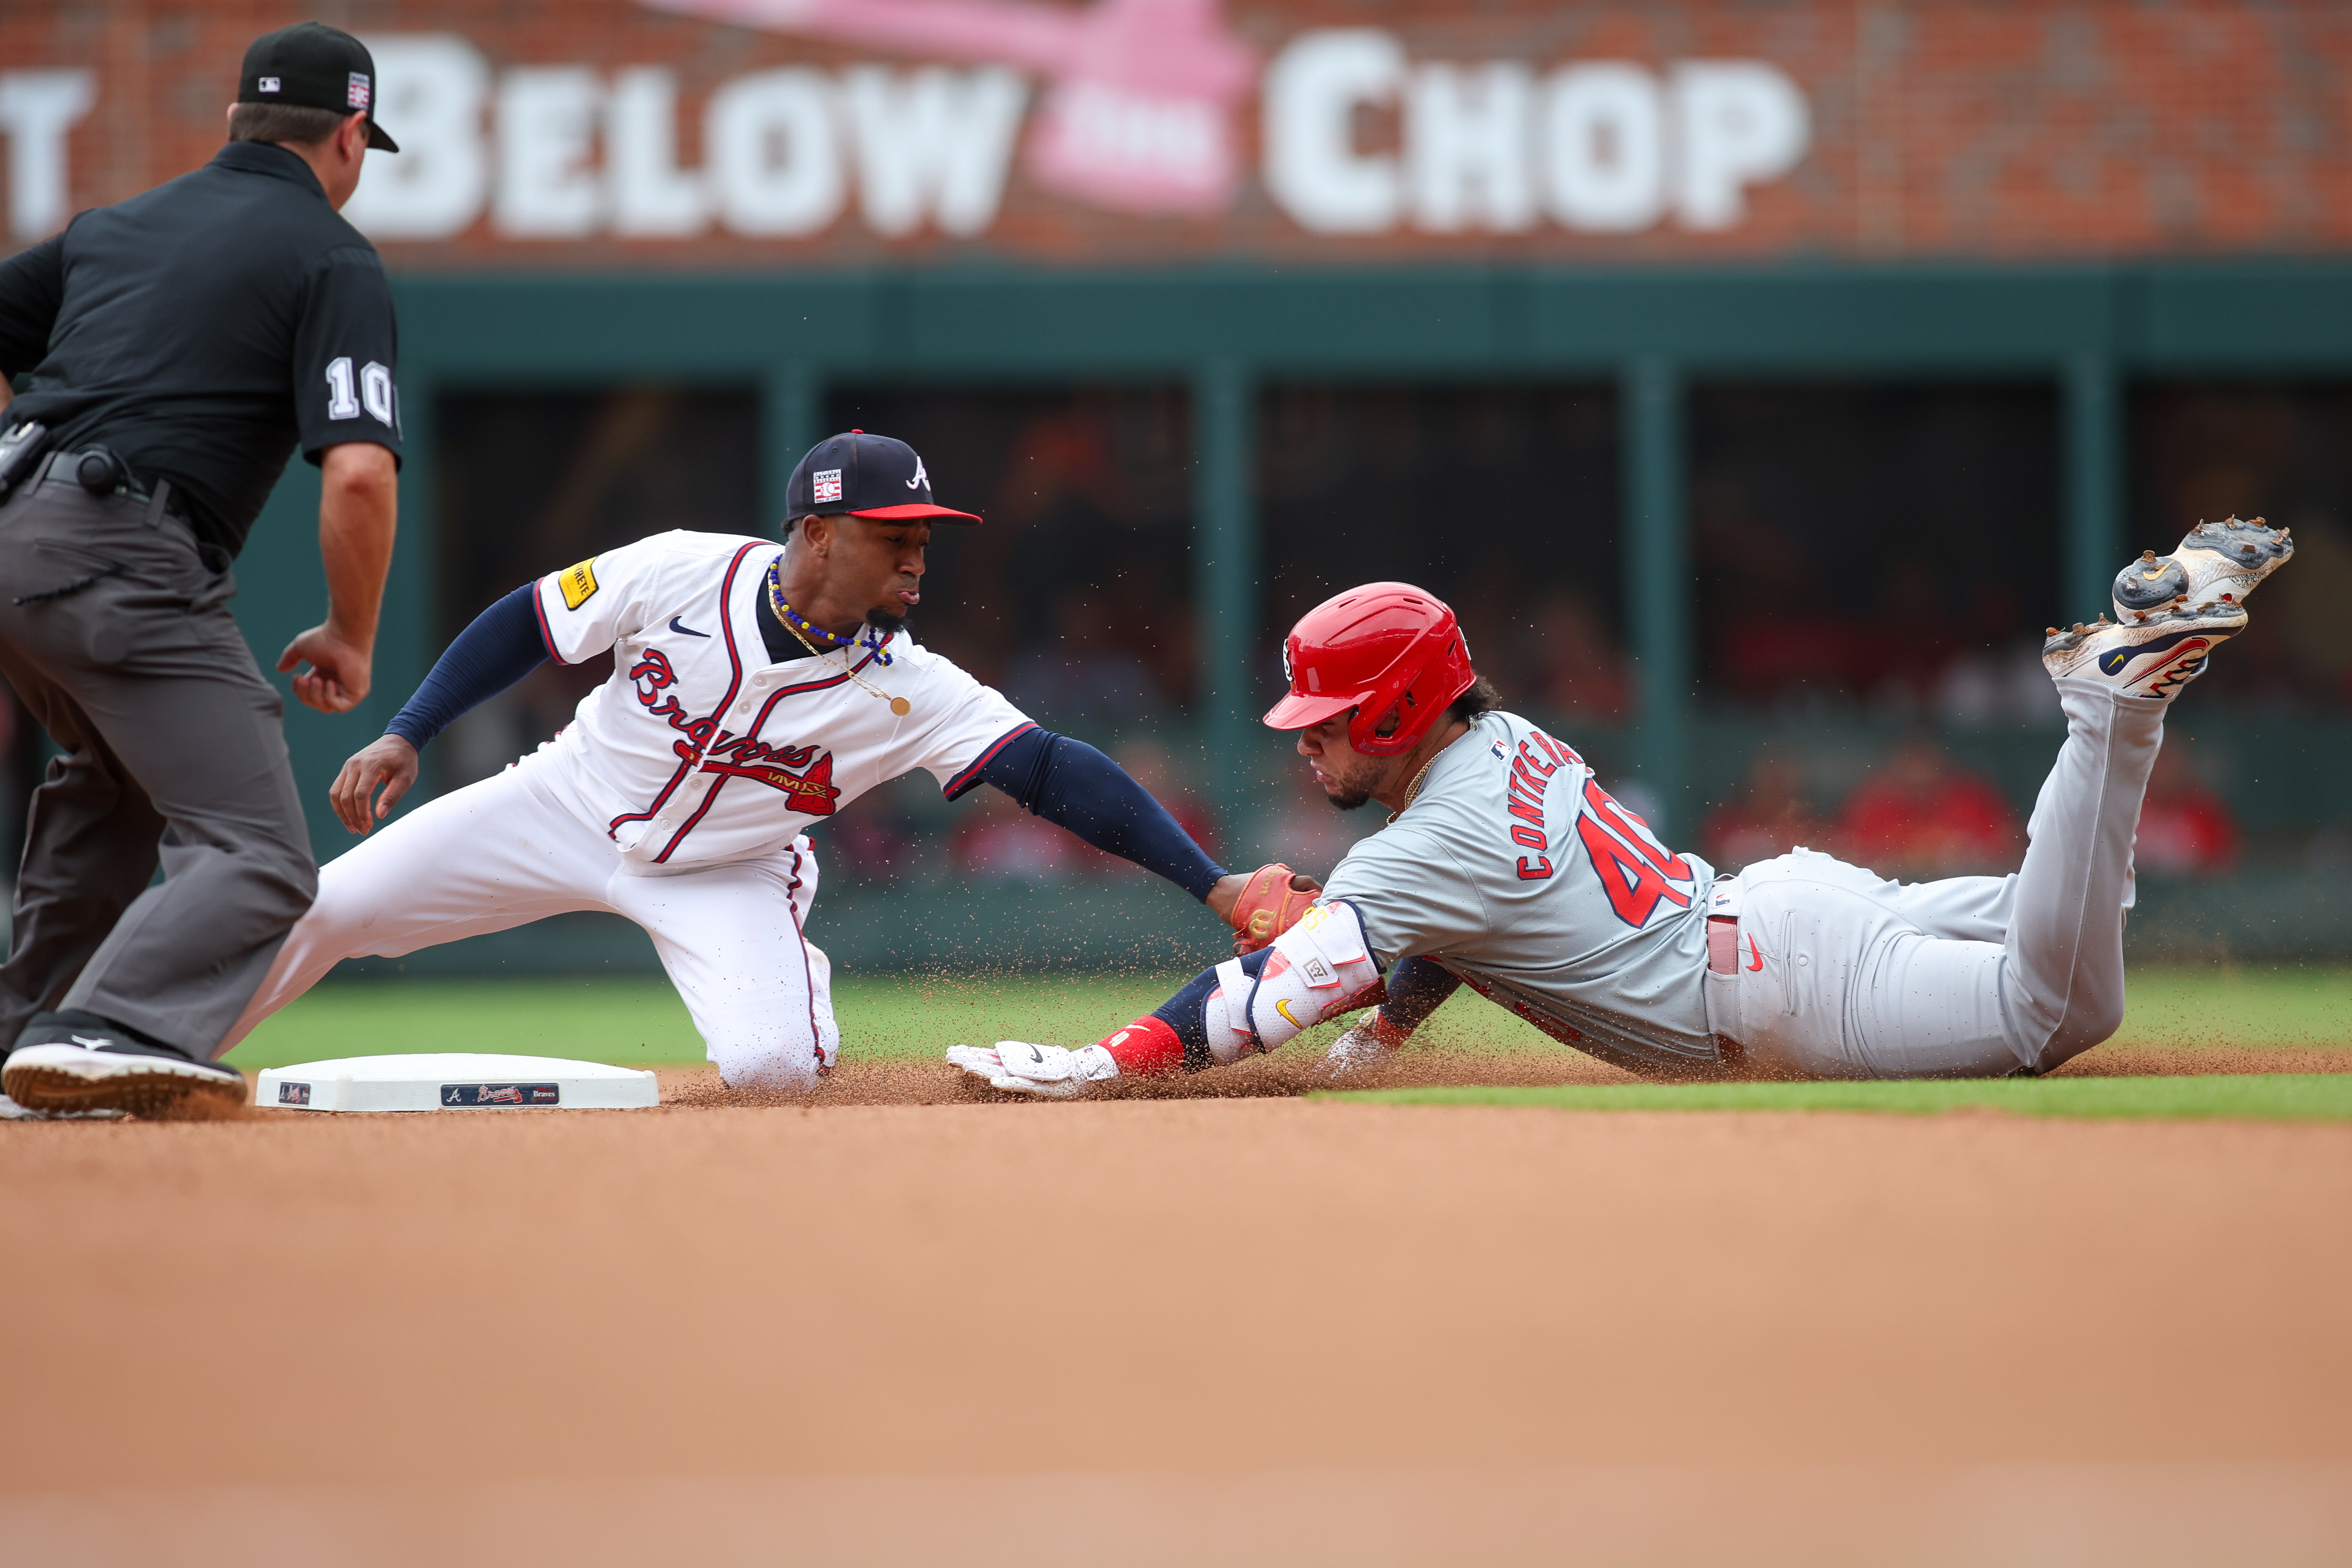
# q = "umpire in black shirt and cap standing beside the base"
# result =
<box><xmin>0</xmin><ymin>21</ymin><xmax>400</xmax><ymax>1116</ymax></box>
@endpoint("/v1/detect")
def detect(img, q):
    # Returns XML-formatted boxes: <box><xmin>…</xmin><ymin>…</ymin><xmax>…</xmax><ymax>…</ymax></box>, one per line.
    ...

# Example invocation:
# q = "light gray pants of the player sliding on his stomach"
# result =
<box><xmin>1705</xmin><ymin>679</ymin><xmax>2168</xmax><ymax>1079</ymax></box>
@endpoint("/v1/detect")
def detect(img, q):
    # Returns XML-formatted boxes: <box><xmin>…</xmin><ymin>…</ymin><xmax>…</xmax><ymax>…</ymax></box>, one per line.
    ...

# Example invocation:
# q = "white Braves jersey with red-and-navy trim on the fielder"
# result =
<box><xmin>527</xmin><ymin>531</ymin><xmax>1033</xmax><ymax>868</ymax></box>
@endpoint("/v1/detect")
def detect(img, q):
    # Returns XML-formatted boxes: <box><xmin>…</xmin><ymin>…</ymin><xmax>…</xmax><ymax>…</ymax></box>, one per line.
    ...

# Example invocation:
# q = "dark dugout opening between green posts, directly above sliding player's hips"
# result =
<box><xmin>1689</xmin><ymin>383</ymin><xmax>2060</xmax><ymax>726</ymax></box>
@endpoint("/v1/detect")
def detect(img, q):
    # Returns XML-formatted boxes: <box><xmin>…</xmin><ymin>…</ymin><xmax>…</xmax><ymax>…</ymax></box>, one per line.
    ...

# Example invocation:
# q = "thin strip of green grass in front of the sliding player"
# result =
<box><xmin>1315</xmin><ymin>1072</ymin><xmax>2352</xmax><ymax>1121</ymax></box>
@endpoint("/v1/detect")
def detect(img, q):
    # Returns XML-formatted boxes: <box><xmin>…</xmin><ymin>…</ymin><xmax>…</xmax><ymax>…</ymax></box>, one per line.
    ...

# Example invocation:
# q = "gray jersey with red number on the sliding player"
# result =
<box><xmin>1324</xmin><ymin>712</ymin><xmax>1715</xmax><ymax>1070</ymax></box>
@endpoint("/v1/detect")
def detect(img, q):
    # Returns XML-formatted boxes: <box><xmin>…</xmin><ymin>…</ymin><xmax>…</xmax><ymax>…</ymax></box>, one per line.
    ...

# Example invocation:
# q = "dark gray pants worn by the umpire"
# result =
<box><xmin>0</xmin><ymin>465</ymin><xmax>317</xmax><ymax>1060</ymax></box>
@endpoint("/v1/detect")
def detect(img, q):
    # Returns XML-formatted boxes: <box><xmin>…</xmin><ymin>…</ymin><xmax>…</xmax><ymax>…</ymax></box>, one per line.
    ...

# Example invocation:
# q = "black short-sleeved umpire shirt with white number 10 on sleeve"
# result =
<box><xmin>0</xmin><ymin>141</ymin><xmax>400</xmax><ymax>555</ymax></box>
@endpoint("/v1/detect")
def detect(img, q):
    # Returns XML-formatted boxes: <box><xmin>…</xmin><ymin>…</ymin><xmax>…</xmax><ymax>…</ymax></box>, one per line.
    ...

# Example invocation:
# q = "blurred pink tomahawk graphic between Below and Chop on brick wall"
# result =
<box><xmin>642</xmin><ymin>0</ymin><xmax>1258</xmax><ymax>214</ymax></box>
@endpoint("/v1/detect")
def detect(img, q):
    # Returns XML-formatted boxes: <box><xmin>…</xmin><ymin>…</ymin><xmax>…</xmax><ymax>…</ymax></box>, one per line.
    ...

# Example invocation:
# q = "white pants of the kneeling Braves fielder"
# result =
<box><xmin>221</xmin><ymin>759</ymin><xmax>842</xmax><ymax>1088</ymax></box>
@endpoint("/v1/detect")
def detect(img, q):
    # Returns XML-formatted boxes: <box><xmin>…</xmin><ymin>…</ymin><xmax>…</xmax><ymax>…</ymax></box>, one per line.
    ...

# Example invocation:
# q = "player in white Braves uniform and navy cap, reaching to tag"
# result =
<box><xmin>224</xmin><ymin>430</ymin><xmax>1244</xmax><ymax>1088</ymax></box>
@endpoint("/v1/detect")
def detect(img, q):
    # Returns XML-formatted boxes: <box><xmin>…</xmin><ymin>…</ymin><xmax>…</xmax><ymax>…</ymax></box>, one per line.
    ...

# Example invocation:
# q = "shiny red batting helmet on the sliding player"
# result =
<box><xmin>1265</xmin><ymin>583</ymin><xmax>1477</xmax><ymax>757</ymax></box>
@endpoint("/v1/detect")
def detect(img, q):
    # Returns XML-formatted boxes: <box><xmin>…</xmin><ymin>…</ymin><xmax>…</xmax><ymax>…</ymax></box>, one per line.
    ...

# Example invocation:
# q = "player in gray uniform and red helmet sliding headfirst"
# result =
<box><xmin>948</xmin><ymin>517</ymin><xmax>2293</xmax><ymax>1098</ymax></box>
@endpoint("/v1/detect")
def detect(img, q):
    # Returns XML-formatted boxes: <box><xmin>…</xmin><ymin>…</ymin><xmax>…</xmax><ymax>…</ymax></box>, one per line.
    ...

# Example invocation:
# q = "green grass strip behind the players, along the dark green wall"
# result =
<box><xmin>228</xmin><ymin>966</ymin><xmax>2352</xmax><ymax>1070</ymax></box>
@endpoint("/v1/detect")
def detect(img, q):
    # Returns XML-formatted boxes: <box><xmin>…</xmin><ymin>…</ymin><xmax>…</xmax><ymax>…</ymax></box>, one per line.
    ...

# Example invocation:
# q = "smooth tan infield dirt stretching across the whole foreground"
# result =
<box><xmin>0</xmin><ymin>1081</ymin><xmax>2352</xmax><ymax>1563</ymax></box>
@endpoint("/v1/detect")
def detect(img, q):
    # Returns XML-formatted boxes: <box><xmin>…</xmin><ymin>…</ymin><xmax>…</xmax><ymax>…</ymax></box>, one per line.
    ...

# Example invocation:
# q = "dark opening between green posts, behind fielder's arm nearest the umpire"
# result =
<box><xmin>428</xmin><ymin>386</ymin><xmax>774</xmax><ymax>790</ymax></box>
